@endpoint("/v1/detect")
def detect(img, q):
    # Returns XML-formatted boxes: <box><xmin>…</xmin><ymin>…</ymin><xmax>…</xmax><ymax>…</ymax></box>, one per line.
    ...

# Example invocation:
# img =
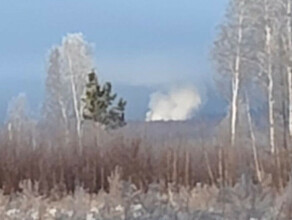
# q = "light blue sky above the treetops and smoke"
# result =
<box><xmin>0</xmin><ymin>0</ymin><xmax>228</xmax><ymax>119</ymax></box>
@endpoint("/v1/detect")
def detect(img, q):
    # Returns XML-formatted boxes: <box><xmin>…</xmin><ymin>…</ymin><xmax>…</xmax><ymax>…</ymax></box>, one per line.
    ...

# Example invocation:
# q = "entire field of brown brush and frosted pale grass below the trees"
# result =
<box><xmin>0</xmin><ymin>122</ymin><xmax>292</xmax><ymax>220</ymax></box>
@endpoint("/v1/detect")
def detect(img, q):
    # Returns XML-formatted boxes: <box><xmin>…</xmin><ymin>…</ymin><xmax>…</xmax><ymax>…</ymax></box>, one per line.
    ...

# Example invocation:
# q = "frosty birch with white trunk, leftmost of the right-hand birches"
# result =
<box><xmin>213</xmin><ymin>0</ymin><xmax>250</xmax><ymax>146</ymax></box>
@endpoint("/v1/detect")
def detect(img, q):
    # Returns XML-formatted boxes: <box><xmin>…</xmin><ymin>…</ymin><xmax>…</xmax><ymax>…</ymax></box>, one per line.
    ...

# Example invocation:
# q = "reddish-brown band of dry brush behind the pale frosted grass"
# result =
<box><xmin>0</xmin><ymin>124</ymin><xmax>291</xmax><ymax>197</ymax></box>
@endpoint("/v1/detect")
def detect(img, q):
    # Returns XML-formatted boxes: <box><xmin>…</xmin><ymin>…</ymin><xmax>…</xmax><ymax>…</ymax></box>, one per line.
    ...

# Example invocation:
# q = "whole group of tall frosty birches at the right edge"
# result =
<box><xmin>212</xmin><ymin>0</ymin><xmax>292</xmax><ymax>154</ymax></box>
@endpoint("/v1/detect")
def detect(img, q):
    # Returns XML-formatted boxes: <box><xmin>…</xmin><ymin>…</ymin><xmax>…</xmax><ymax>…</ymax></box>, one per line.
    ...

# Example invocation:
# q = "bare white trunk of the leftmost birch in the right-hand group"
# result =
<box><xmin>230</xmin><ymin>7</ymin><xmax>243</xmax><ymax>146</ymax></box>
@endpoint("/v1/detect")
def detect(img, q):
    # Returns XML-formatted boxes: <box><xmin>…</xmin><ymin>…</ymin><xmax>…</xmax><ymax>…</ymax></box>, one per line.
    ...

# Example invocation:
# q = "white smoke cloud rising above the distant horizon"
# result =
<box><xmin>146</xmin><ymin>86</ymin><xmax>201</xmax><ymax>121</ymax></box>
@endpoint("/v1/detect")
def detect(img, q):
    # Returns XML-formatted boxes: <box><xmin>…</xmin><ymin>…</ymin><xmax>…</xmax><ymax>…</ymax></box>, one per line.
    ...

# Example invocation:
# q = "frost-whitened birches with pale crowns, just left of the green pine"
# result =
<box><xmin>45</xmin><ymin>34</ymin><xmax>94</xmax><ymax>144</ymax></box>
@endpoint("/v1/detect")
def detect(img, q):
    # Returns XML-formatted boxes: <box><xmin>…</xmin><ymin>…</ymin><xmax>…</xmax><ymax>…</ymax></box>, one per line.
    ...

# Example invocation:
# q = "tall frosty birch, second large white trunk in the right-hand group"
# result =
<box><xmin>251</xmin><ymin>0</ymin><xmax>280</xmax><ymax>154</ymax></box>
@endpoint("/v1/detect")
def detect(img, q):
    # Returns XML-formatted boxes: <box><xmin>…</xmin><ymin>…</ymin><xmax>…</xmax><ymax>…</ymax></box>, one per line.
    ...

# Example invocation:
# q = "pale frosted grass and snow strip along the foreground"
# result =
<box><xmin>0</xmin><ymin>175</ymin><xmax>292</xmax><ymax>220</ymax></box>
